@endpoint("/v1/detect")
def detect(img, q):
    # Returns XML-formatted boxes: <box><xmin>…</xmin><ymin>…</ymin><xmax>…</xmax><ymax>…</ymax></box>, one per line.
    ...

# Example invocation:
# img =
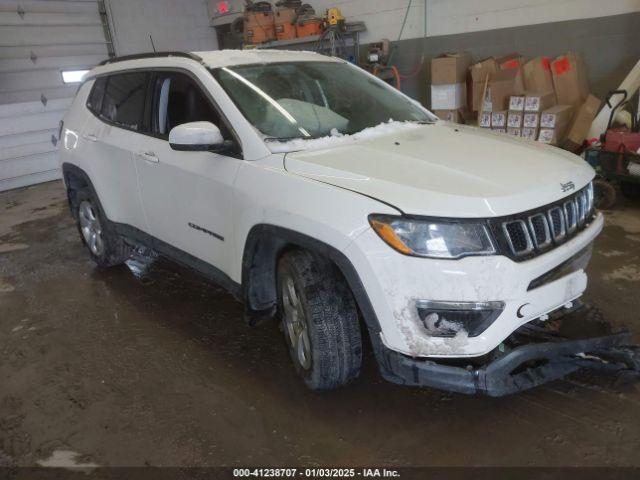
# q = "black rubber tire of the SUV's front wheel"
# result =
<box><xmin>278</xmin><ymin>250</ymin><xmax>362</xmax><ymax>390</ymax></box>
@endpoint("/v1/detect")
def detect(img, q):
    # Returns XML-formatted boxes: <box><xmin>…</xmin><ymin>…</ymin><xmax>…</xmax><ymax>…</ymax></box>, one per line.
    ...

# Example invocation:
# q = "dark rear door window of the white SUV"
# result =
<box><xmin>100</xmin><ymin>72</ymin><xmax>149</xmax><ymax>131</ymax></box>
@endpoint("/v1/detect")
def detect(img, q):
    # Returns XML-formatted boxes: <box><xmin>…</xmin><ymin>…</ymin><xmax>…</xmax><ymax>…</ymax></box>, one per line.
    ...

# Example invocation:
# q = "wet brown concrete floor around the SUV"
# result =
<box><xmin>0</xmin><ymin>182</ymin><xmax>640</xmax><ymax>466</ymax></box>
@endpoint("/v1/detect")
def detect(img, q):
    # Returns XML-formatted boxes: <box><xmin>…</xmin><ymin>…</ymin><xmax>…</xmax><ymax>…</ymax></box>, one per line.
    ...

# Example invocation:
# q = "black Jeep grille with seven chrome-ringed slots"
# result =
<box><xmin>490</xmin><ymin>186</ymin><xmax>594</xmax><ymax>260</ymax></box>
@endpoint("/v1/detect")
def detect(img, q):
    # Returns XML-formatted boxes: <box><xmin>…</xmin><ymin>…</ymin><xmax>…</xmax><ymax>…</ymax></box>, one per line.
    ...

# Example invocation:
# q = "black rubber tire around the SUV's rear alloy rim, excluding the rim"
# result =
<box><xmin>73</xmin><ymin>188</ymin><xmax>132</xmax><ymax>268</ymax></box>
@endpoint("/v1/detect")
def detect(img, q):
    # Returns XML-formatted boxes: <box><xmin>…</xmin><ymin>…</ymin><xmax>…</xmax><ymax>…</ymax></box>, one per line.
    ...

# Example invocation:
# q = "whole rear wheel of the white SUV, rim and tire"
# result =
<box><xmin>75</xmin><ymin>189</ymin><xmax>131</xmax><ymax>267</ymax></box>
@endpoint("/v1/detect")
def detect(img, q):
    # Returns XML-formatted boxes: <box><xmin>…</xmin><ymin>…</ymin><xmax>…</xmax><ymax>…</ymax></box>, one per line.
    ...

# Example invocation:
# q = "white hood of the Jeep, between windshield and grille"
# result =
<box><xmin>285</xmin><ymin>122</ymin><xmax>594</xmax><ymax>218</ymax></box>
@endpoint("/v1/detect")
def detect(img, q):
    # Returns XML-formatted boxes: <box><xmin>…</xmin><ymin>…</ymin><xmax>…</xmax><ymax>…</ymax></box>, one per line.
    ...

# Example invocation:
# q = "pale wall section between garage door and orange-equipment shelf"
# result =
<box><xmin>105</xmin><ymin>0</ymin><xmax>218</xmax><ymax>55</ymax></box>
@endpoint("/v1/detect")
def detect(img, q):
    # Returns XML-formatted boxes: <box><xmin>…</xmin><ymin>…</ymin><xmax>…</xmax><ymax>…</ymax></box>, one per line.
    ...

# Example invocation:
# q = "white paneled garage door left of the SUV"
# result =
<box><xmin>0</xmin><ymin>0</ymin><xmax>113</xmax><ymax>191</ymax></box>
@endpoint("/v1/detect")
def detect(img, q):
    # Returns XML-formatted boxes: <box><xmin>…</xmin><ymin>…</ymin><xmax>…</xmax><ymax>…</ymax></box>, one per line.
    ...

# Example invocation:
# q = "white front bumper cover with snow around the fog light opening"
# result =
<box><xmin>345</xmin><ymin>214</ymin><xmax>604</xmax><ymax>358</ymax></box>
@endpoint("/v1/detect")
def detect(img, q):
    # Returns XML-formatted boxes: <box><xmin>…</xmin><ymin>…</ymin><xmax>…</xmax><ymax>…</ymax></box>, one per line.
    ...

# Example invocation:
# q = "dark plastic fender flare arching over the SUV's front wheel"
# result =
<box><xmin>242</xmin><ymin>224</ymin><xmax>381</xmax><ymax>333</ymax></box>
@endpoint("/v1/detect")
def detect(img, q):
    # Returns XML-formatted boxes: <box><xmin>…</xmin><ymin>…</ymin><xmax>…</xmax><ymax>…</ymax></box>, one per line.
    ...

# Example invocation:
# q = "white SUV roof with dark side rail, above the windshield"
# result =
<box><xmin>85</xmin><ymin>49</ymin><xmax>344</xmax><ymax>80</ymax></box>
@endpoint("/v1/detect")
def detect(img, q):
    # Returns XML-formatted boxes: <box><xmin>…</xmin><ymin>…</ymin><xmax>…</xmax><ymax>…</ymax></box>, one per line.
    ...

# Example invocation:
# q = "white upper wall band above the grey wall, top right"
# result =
<box><xmin>309</xmin><ymin>0</ymin><xmax>640</xmax><ymax>43</ymax></box>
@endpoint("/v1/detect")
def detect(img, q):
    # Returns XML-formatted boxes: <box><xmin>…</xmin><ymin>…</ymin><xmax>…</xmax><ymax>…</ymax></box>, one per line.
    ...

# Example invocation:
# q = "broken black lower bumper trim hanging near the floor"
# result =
<box><xmin>372</xmin><ymin>331</ymin><xmax>640</xmax><ymax>397</ymax></box>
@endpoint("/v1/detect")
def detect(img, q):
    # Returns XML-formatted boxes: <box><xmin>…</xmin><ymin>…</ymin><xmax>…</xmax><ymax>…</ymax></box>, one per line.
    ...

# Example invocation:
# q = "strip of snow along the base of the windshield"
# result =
<box><xmin>266</xmin><ymin>121</ymin><xmax>422</xmax><ymax>153</ymax></box>
